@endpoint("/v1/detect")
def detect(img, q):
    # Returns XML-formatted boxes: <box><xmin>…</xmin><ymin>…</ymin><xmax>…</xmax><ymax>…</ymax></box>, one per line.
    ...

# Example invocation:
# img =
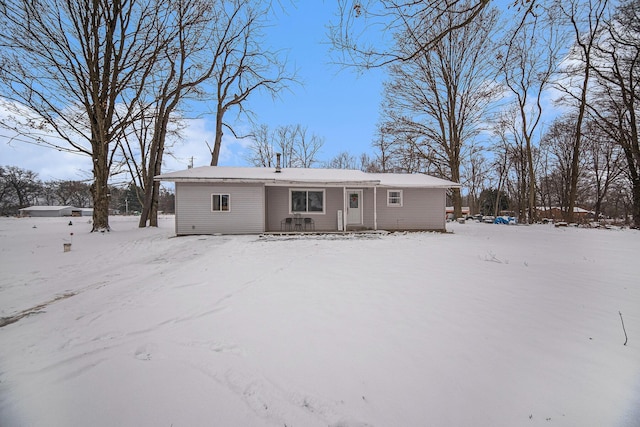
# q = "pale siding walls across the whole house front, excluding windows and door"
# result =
<box><xmin>175</xmin><ymin>182</ymin><xmax>446</xmax><ymax>235</ymax></box>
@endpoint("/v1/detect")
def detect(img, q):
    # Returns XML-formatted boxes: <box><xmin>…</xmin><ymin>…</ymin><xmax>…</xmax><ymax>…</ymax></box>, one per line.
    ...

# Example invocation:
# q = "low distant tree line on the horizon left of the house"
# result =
<box><xmin>0</xmin><ymin>166</ymin><xmax>175</xmax><ymax>216</ymax></box>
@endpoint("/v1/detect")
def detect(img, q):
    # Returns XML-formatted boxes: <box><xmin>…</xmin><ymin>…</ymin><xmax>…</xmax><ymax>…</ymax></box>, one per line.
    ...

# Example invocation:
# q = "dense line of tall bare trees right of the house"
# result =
<box><xmin>330</xmin><ymin>0</ymin><xmax>640</xmax><ymax>227</ymax></box>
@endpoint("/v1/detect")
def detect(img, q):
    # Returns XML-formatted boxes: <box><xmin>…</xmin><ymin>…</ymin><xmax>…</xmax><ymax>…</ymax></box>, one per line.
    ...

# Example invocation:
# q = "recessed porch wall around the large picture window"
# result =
<box><xmin>265</xmin><ymin>186</ymin><xmax>344</xmax><ymax>231</ymax></box>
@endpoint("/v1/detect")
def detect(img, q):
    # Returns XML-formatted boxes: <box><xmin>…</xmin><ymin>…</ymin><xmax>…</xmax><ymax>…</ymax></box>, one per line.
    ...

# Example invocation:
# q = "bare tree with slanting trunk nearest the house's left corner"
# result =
<box><xmin>123</xmin><ymin>0</ymin><xmax>226</xmax><ymax>227</ymax></box>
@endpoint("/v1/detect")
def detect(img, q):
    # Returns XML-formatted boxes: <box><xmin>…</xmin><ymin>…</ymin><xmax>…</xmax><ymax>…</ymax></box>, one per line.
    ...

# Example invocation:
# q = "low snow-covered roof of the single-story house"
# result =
<box><xmin>154</xmin><ymin>166</ymin><xmax>460</xmax><ymax>188</ymax></box>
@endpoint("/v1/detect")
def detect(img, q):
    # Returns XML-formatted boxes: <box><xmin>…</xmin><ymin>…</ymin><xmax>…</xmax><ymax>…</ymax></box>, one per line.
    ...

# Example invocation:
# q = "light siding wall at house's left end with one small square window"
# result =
<box><xmin>176</xmin><ymin>182</ymin><xmax>265</xmax><ymax>235</ymax></box>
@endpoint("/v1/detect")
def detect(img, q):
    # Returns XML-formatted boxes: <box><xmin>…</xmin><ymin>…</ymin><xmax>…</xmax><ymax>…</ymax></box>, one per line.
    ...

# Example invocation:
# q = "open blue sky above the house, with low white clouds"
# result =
<box><xmin>0</xmin><ymin>0</ymin><xmax>384</xmax><ymax>181</ymax></box>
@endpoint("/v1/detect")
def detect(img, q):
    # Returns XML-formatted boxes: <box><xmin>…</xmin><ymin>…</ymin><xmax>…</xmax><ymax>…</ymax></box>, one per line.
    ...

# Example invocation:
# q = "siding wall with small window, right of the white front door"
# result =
<box><xmin>377</xmin><ymin>188</ymin><xmax>446</xmax><ymax>230</ymax></box>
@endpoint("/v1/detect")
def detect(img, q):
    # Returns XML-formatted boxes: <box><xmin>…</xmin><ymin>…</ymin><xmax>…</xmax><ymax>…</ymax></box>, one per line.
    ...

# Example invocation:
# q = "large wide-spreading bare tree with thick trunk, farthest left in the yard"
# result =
<box><xmin>0</xmin><ymin>0</ymin><xmax>168</xmax><ymax>231</ymax></box>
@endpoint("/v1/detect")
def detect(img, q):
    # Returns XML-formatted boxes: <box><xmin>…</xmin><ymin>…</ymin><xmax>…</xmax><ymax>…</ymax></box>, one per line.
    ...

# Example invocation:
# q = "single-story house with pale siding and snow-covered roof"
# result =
<box><xmin>155</xmin><ymin>166</ymin><xmax>459</xmax><ymax>235</ymax></box>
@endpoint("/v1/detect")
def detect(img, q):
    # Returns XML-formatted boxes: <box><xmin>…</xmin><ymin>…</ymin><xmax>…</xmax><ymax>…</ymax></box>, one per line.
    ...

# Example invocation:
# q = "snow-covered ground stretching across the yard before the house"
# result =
<box><xmin>0</xmin><ymin>217</ymin><xmax>640</xmax><ymax>427</ymax></box>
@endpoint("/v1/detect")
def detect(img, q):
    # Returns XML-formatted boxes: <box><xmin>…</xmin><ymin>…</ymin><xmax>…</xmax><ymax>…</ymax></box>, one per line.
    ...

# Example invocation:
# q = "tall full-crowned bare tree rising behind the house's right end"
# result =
<box><xmin>385</xmin><ymin>2</ymin><xmax>497</xmax><ymax>216</ymax></box>
